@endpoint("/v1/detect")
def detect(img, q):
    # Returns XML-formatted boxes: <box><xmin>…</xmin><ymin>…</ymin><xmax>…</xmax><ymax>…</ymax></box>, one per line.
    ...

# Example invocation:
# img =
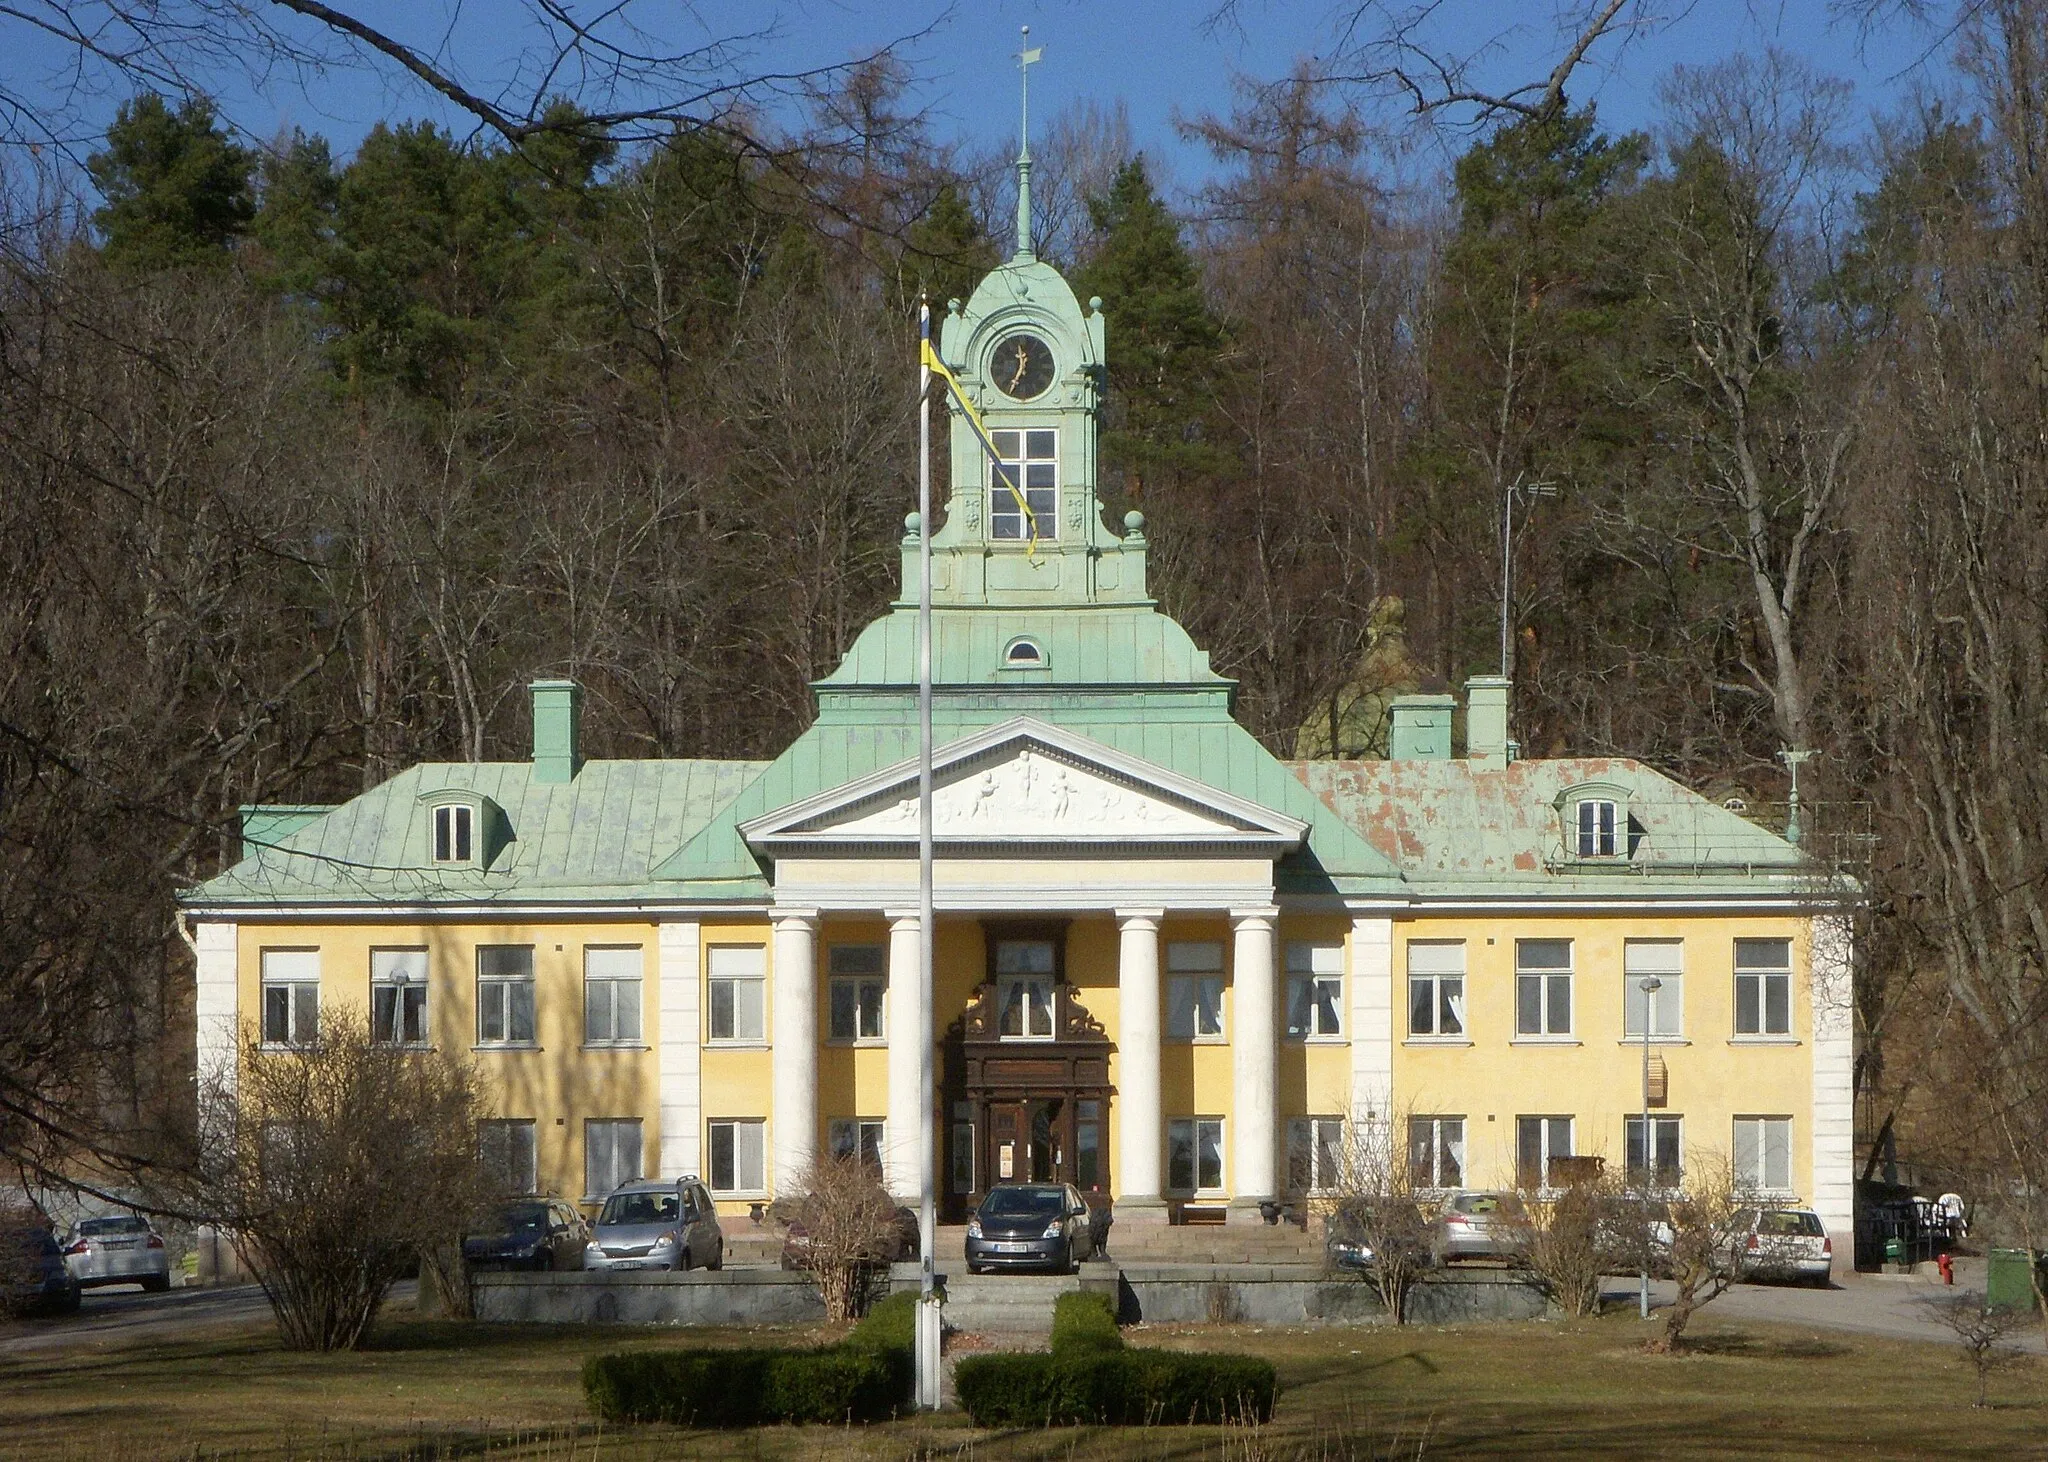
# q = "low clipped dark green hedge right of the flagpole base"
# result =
<box><xmin>954</xmin><ymin>1345</ymin><xmax>1276</xmax><ymax>1427</ymax></box>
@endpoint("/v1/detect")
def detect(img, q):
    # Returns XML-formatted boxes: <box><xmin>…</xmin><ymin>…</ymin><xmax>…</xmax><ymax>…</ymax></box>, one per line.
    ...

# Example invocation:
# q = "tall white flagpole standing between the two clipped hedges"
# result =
<box><xmin>915</xmin><ymin>299</ymin><xmax>942</xmax><ymax>1411</ymax></box>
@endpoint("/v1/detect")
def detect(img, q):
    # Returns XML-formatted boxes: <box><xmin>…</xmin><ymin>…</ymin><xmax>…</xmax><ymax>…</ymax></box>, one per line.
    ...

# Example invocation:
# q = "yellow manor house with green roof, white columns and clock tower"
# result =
<box><xmin>186</xmin><ymin>190</ymin><xmax>1853</xmax><ymax>1263</ymax></box>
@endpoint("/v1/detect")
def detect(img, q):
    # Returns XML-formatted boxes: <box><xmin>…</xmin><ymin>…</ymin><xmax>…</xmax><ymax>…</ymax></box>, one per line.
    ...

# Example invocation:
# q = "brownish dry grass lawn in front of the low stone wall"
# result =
<box><xmin>0</xmin><ymin>1310</ymin><xmax>2048</xmax><ymax>1462</ymax></box>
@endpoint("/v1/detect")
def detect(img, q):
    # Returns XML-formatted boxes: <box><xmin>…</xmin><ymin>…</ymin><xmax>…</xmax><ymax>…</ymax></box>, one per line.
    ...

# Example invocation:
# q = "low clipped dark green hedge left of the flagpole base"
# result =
<box><xmin>584</xmin><ymin>1345</ymin><xmax>909</xmax><ymax>1427</ymax></box>
